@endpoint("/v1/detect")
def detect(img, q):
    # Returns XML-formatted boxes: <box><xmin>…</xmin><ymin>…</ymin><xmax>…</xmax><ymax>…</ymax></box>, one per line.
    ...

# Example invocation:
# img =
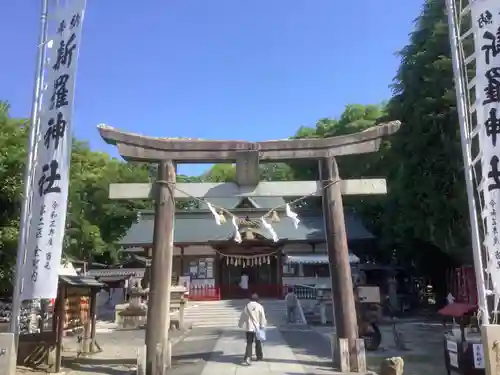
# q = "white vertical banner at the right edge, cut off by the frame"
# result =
<box><xmin>471</xmin><ymin>0</ymin><xmax>500</xmax><ymax>295</ymax></box>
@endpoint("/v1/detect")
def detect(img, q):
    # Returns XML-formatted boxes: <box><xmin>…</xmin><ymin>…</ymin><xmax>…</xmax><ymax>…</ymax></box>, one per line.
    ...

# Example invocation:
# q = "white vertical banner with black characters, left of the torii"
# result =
<box><xmin>21</xmin><ymin>0</ymin><xmax>85</xmax><ymax>300</ymax></box>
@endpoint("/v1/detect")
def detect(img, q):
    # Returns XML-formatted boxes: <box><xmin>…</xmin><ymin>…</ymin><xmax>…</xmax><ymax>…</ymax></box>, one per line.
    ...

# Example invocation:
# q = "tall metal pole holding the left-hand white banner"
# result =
<box><xmin>10</xmin><ymin>0</ymin><xmax>49</xmax><ymax>338</ymax></box>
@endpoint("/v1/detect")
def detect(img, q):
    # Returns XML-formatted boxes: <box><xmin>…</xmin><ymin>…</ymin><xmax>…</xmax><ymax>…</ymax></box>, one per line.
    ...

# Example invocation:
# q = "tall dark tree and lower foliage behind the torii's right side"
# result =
<box><xmin>201</xmin><ymin>0</ymin><xmax>471</xmax><ymax>261</ymax></box>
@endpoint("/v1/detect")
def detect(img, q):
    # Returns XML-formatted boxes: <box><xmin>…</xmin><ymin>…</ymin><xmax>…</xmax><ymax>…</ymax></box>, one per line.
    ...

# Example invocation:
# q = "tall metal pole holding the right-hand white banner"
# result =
<box><xmin>446</xmin><ymin>0</ymin><xmax>490</xmax><ymax>324</ymax></box>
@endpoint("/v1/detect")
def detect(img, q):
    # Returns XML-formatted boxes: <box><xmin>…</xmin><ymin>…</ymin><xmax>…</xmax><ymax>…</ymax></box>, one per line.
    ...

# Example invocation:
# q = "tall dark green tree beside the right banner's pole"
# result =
<box><xmin>378</xmin><ymin>0</ymin><xmax>470</xmax><ymax>260</ymax></box>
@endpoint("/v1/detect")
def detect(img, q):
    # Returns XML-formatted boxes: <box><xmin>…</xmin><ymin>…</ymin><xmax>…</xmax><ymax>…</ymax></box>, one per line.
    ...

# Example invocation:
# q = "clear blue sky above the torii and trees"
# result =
<box><xmin>0</xmin><ymin>0</ymin><xmax>423</xmax><ymax>174</ymax></box>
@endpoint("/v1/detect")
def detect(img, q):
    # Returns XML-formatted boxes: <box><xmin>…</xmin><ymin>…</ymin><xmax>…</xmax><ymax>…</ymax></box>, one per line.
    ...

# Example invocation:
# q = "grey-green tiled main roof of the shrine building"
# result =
<box><xmin>120</xmin><ymin>210</ymin><xmax>374</xmax><ymax>246</ymax></box>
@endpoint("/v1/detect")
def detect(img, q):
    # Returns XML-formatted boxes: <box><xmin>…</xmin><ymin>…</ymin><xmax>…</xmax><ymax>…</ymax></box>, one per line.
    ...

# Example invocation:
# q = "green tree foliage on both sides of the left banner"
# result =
<box><xmin>0</xmin><ymin>102</ymin><xmax>150</xmax><ymax>288</ymax></box>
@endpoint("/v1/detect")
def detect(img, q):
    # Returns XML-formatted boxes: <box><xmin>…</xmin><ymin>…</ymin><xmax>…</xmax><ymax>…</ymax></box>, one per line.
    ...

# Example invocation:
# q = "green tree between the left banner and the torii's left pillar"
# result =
<box><xmin>65</xmin><ymin>140</ymin><xmax>151</xmax><ymax>263</ymax></box>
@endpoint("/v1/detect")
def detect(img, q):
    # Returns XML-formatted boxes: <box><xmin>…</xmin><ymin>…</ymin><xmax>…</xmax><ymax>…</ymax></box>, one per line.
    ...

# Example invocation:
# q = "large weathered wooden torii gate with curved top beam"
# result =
<box><xmin>98</xmin><ymin>121</ymin><xmax>400</xmax><ymax>375</ymax></box>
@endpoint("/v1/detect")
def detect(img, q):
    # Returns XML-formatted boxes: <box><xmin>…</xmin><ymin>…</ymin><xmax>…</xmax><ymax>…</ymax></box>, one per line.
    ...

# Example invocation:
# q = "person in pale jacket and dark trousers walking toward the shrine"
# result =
<box><xmin>238</xmin><ymin>294</ymin><xmax>267</xmax><ymax>365</ymax></box>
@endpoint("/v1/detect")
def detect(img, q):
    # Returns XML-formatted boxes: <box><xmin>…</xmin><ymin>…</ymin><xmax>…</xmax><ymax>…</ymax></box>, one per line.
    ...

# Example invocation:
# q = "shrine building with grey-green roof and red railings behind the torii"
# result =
<box><xmin>89</xmin><ymin>197</ymin><xmax>375</xmax><ymax>299</ymax></box>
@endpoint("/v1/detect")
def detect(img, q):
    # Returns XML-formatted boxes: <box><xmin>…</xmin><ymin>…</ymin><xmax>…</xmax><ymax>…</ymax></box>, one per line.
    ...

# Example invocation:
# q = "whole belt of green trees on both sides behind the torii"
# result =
<box><xmin>0</xmin><ymin>0</ymin><xmax>470</xmax><ymax>290</ymax></box>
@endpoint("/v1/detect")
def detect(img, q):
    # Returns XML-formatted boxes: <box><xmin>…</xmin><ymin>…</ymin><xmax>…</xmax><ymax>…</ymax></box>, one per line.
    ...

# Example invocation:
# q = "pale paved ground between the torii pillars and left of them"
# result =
<box><xmin>16</xmin><ymin>327</ymin><xmax>352</xmax><ymax>375</ymax></box>
